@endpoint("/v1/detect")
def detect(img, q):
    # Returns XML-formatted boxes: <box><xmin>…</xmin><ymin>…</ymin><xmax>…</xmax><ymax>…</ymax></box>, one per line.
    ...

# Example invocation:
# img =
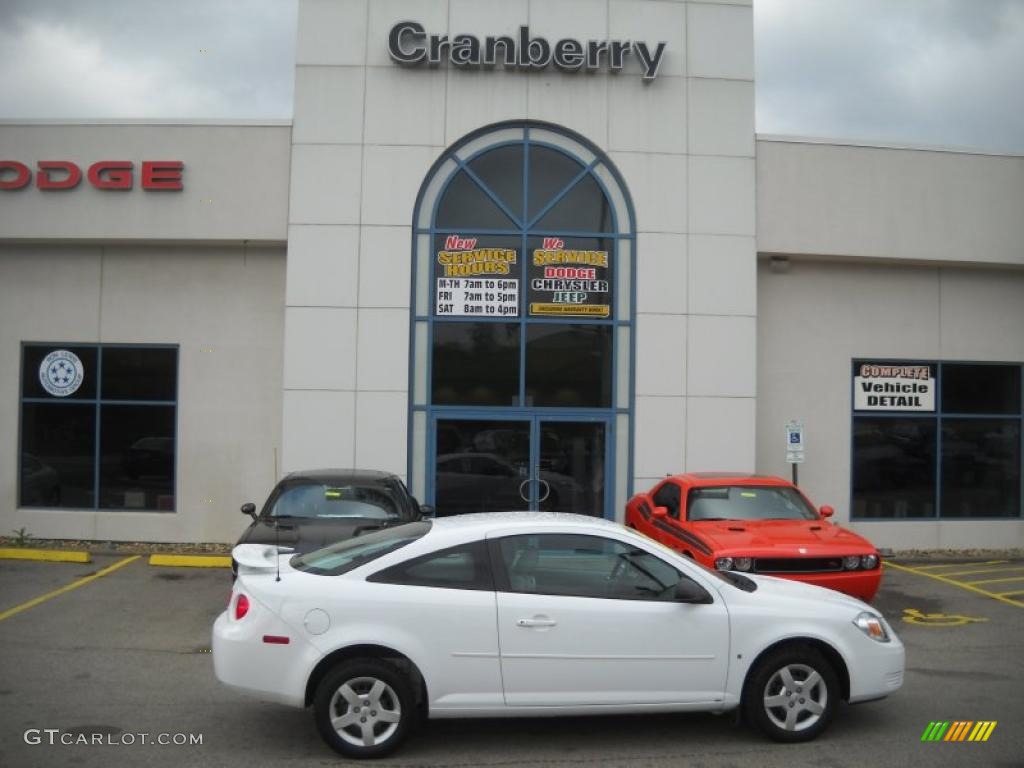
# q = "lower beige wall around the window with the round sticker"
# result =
<box><xmin>0</xmin><ymin>245</ymin><xmax>285</xmax><ymax>542</ymax></box>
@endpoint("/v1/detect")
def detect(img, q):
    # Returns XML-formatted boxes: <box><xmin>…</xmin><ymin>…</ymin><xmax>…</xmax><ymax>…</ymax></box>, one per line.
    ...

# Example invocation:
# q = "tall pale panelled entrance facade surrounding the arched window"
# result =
<box><xmin>284</xmin><ymin>0</ymin><xmax>756</xmax><ymax>513</ymax></box>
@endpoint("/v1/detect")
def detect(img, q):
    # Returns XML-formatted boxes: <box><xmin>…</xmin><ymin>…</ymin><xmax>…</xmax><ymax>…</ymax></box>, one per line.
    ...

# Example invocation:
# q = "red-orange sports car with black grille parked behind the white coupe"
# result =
<box><xmin>626</xmin><ymin>473</ymin><xmax>882</xmax><ymax>600</ymax></box>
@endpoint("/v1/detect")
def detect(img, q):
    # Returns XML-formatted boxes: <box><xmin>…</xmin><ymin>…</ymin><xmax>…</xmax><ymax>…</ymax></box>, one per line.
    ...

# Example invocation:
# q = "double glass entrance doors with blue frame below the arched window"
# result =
<box><xmin>432</xmin><ymin>416</ymin><xmax>610</xmax><ymax>517</ymax></box>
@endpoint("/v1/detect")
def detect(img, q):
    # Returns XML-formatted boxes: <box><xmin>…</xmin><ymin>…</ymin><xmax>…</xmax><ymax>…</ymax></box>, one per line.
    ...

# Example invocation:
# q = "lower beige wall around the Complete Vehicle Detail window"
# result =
<box><xmin>757</xmin><ymin>259</ymin><xmax>1024</xmax><ymax>549</ymax></box>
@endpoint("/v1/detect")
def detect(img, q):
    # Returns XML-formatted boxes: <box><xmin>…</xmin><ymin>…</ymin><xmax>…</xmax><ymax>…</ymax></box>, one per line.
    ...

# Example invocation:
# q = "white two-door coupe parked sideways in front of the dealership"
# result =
<box><xmin>213</xmin><ymin>512</ymin><xmax>904</xmax><ymax>758</ymax></box>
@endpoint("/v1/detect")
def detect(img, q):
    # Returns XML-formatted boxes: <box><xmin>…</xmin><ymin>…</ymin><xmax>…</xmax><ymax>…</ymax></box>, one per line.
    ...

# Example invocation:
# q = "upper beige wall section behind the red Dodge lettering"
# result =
<box><xmin>0</xmin><ymin>122</ymin><xmax>291</xmax><ymax>243</ymax></box>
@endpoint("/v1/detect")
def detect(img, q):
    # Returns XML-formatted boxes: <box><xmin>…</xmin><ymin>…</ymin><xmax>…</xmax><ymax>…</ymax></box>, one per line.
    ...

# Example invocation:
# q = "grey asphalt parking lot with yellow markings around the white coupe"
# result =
<box><xmin>0</xmin><ymin>556</ymin><xmax>1024</xmax><ymax>768</ymax></box>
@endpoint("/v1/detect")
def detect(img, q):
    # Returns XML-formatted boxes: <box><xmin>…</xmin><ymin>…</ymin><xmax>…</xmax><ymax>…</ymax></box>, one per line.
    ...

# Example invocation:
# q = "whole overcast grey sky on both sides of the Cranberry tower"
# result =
<box><xmin>0</xmin><ymin>0</ymin><xmax>1024</xmax><ymax>153</ymax></box>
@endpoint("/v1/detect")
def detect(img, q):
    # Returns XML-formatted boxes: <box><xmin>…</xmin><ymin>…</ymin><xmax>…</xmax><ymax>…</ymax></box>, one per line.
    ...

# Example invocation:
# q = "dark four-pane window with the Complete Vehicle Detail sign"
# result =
<box><xmin>850</xmin><ymin>358</ymin><xmax>1024</xmax><ymax>520</ymax></box>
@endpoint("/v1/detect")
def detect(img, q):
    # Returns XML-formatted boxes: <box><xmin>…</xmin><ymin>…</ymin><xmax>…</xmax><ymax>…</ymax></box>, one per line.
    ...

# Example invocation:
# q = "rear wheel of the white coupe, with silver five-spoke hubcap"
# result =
<box><xmin>313</xmin><ymin>658</ymin><xmax>417</xmax><ymax>759</ymax></box>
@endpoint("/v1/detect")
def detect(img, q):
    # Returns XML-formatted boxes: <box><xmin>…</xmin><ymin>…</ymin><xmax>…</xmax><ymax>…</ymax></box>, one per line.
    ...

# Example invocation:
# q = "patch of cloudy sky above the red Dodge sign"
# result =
<box><xmin>0</xmin><ymin>0</ymin><xmax>296</xmax><ymax>119</ymax></box>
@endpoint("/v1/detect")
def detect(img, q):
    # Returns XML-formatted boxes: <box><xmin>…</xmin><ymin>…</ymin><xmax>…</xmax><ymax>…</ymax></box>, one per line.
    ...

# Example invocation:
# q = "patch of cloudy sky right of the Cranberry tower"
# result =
<box><xmin>754</xmin><ymin>0</ymin><xmax>1024</xmax><ymax>152</ymax></box>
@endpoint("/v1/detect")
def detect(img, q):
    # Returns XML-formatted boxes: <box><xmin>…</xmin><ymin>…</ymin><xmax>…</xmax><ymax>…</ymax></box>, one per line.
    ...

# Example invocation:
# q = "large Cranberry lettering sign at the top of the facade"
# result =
<box><xmin>387</xmin><ymin>22</ymin><xmax>667</xmax><ymax>83</ymax></box>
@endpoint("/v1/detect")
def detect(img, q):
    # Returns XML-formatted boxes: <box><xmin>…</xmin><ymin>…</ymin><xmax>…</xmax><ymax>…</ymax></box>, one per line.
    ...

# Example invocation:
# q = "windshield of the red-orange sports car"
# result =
<box><xmin>686</xmin><ymin>485</ymin><xmax>818</xmax><ymax>521</ymax></box>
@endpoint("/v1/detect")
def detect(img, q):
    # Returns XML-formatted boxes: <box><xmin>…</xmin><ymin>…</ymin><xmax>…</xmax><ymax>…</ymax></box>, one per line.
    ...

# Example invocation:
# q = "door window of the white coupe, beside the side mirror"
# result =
<box><xmin>493</xmin><ymin>534</ymin><xmax>682</xmax><ymax>600</ymax></box>
